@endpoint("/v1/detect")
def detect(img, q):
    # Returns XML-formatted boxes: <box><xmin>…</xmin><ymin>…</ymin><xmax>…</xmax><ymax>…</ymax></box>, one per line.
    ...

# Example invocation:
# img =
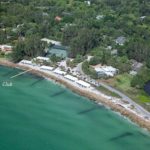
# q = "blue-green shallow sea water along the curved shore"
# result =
<box><xmin>0</xmin><ymin>66</ymin><xmax>150</xmax><ymax>150</ymax></box>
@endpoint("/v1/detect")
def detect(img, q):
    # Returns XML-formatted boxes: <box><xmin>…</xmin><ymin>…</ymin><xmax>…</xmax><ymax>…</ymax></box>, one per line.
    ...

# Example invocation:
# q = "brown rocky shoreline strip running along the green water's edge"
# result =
<box><xmin>0</xmin><ymin>60</ymin><xmax>150</xmax><ymax>131</ymax></box>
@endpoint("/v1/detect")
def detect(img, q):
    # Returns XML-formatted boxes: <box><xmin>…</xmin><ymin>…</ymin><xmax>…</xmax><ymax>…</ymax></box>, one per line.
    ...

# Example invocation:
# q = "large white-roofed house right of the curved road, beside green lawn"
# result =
<box><xmin>94</xmin><ymin>65</ymin><xmax>118</xmax><ymax>77</ymax></box>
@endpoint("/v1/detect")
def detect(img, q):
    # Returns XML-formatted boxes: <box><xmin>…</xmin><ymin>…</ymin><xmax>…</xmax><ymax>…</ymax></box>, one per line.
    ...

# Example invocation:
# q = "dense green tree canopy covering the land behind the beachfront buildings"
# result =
<box><xmin>0</xmin><ymin>0</ymin><xmax>150</xmax><ymax>92</ymax></box>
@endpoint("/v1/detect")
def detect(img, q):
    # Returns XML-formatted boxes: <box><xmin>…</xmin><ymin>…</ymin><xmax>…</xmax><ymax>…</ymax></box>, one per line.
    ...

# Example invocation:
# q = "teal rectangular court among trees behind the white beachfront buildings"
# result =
<box><xmin>46</xmin><ymin>45</ymin><xmax>68</xmax><ymax>59</ymax></box>
